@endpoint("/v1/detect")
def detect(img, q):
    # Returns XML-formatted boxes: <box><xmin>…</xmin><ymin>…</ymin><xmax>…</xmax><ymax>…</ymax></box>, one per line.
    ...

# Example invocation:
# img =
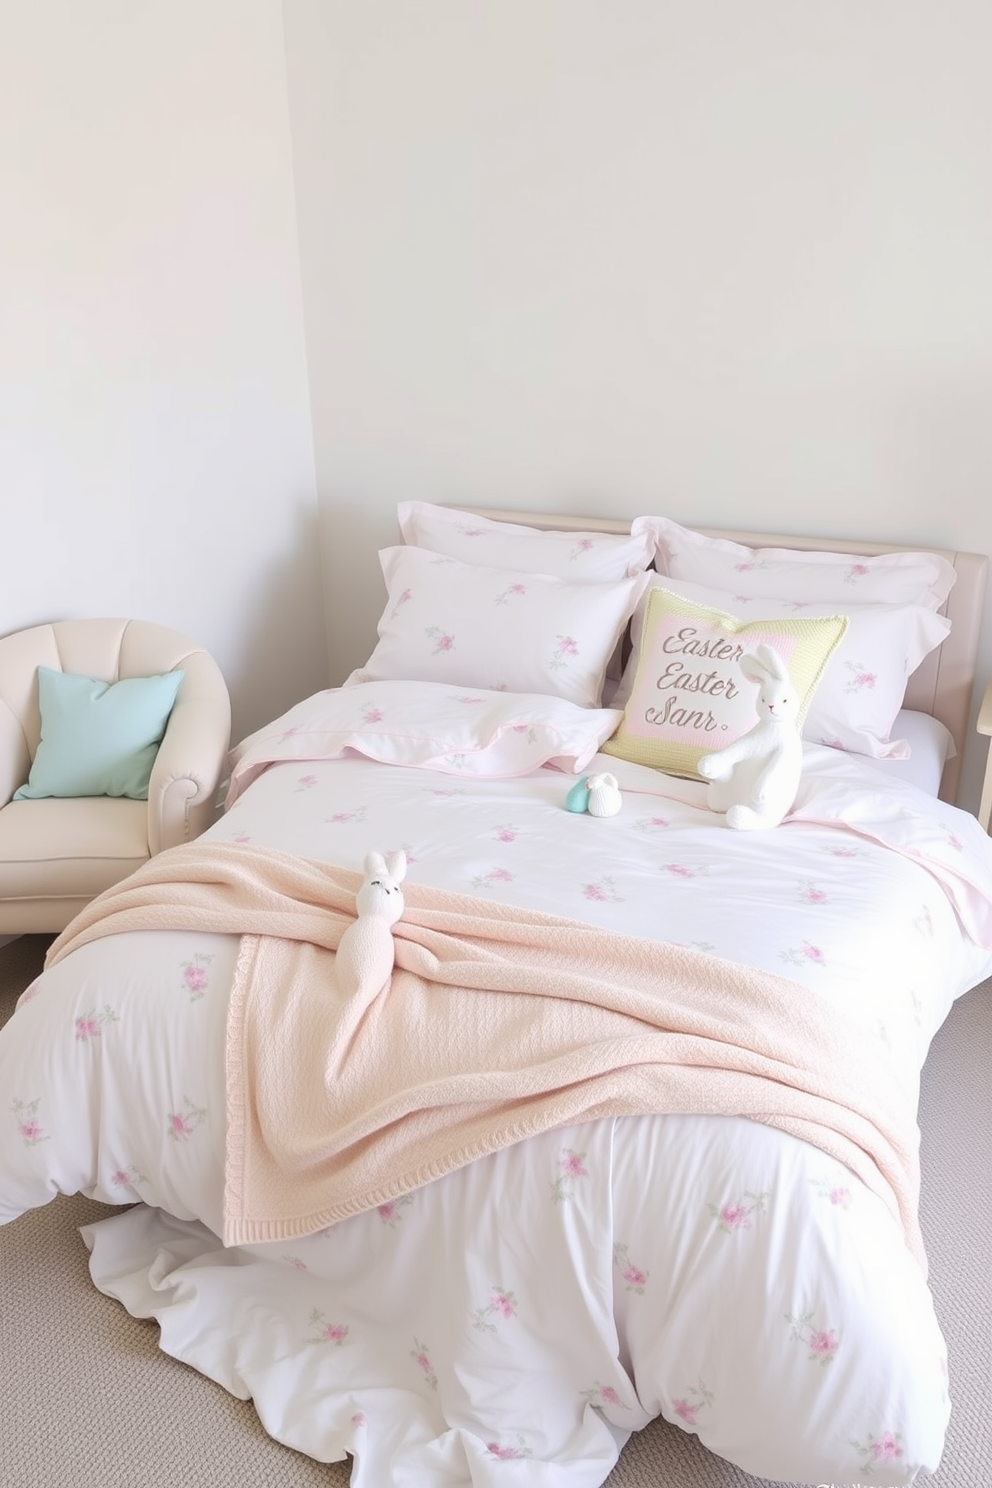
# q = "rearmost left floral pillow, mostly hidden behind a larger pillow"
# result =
<box><xmin>397</xmin><ymin>501</ymin><xmax>654</xmax><ymax>583</ymax></box>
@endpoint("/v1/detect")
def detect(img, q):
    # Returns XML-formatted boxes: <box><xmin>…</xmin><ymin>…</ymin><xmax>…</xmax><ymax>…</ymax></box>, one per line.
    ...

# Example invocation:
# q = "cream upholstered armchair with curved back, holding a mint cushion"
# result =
<box><xmin>0</xmin><ymin>619</ymin><xmax>231</xmax><ymax>934</ymax></box>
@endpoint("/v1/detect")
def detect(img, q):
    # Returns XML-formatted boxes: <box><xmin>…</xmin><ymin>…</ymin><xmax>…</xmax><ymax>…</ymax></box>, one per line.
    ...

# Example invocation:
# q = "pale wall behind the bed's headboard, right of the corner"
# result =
<box><xmin>284</xmin><ymin>0</ymin><xmax>992</xmax><ymax>805</ymax></box>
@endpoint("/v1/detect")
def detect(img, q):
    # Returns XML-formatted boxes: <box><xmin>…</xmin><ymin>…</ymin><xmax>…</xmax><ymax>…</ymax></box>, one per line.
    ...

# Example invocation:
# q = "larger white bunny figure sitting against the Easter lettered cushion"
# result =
<box><xmin>696</xmin><ymin>644</ymin><xmax>803</xmax><ymax>830</ymax></box>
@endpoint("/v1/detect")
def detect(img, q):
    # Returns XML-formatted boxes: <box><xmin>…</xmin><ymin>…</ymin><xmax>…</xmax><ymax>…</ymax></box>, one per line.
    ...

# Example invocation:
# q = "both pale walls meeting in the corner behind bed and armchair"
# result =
<box><xmin>0</xmin><ymin>0</ymin><xmax>992</xmax><ymax>804</ymax></box>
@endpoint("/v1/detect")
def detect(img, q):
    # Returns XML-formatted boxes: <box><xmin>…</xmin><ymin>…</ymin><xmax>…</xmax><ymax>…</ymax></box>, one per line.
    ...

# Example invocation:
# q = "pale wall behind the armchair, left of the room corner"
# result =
<box><xmin>0</xmin><ymin>0</ymin><xmax>326</xmax><ymax>734</ymax></box>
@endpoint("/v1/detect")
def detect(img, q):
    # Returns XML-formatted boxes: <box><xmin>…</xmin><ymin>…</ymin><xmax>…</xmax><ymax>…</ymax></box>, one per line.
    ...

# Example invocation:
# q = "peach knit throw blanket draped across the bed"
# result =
<box><xmin>49</xmin><ymin>839</ymin><xmax>925</xmax><ymax>1266</ymax></box>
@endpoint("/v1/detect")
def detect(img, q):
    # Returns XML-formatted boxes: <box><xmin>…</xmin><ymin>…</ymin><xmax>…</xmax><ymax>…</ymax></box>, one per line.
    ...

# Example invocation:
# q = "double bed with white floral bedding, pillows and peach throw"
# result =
<box><xmin>0</xmin><ymin>503</ymin><xmax>992</xmax><ymax>1488</ymax></box>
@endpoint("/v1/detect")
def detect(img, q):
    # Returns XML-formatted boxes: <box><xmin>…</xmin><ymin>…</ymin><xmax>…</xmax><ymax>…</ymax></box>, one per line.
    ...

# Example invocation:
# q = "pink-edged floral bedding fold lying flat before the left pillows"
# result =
<box><xmin>225</xmin><ymin>682</ymin><xmax>622</xmax><ymax>806</ymax></box>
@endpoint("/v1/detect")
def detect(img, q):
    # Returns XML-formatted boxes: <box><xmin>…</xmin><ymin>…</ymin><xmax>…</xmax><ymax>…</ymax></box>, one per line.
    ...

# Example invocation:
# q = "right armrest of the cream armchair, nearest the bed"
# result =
<box><xmin>149</xmin><ymin>652</ymin><xmax>231</xmax><ymax>856</ymax></box>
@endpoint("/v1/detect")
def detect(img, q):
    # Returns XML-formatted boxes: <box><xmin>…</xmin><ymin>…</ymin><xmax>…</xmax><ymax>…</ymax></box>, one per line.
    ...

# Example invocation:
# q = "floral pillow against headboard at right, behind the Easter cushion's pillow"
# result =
<box><xmin>631</xmin><ymin>516</ymin><xmax>958</xmax><ymax>610</ymax></box>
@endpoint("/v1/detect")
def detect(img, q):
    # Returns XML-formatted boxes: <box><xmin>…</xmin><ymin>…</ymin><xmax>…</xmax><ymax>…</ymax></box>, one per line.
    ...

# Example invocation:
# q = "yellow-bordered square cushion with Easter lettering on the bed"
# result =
<box><xmin>602</xmin><ymin>586</ymin><xmax>848</xmax><ymax>778</ymax></box>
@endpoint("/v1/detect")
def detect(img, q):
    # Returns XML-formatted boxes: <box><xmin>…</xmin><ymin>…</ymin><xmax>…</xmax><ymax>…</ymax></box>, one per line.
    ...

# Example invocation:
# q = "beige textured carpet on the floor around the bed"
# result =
<box><xmin>0</xmin><ymin>936</ymin><xmax>992</xmax><ymax>1488</ymax></box>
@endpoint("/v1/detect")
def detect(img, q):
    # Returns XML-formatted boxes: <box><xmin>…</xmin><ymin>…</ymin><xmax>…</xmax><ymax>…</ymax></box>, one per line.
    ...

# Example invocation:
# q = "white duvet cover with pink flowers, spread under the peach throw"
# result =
<box><xmin>0</xmin><ymin>747</ymin><xmax>992</xmax><ymax>1488</ymax></box>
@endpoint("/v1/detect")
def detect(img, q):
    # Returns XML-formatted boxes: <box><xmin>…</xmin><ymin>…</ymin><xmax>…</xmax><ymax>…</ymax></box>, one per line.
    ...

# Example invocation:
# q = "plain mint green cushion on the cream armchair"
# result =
<box><xmin>13</xmin><ymin>667</ymin><xmax>183</xmax><ymax>801</ymax></box>
